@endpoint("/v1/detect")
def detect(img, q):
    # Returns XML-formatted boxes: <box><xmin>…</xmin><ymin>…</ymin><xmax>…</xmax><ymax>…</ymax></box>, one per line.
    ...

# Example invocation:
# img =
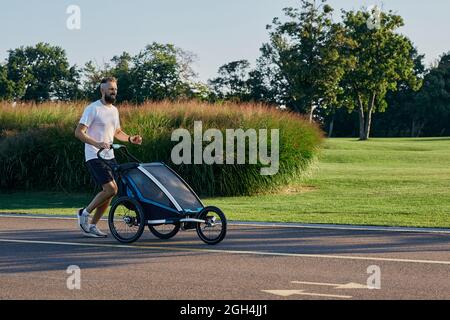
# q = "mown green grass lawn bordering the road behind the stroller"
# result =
<box><xmin>0</xmin><ymin>138</ymin><xmax>450</xmax><ymax>228</ymax></box>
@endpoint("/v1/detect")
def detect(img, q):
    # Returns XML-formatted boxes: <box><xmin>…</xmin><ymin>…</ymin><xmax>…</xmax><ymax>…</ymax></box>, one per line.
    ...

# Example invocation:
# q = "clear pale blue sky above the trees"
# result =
<box><xmin>0</xmin><ymin>0</ymin><xmax>450</xmax><ymax>81</ymax></box>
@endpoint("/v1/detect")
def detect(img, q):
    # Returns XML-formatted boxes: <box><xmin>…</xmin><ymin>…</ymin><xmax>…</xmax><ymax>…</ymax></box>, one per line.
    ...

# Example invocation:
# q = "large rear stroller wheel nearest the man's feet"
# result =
<box><xmin>108</xmin><ymin>197</ymin><xmax>146</xmax><ymax>243</ymax></box>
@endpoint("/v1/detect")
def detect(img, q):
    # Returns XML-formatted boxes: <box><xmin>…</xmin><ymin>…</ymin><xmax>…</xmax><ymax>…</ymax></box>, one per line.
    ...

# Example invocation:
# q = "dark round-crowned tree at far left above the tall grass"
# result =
<box><xmin>7</xmin><ymin>43</ymin><xmax>79</xmax><ymax>102</ymax></box>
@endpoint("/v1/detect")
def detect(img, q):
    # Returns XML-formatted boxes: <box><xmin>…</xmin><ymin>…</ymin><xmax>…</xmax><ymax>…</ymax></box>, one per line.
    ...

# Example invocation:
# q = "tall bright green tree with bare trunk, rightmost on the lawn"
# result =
<box><xmin>341</xmin><ymin>7</ymin><xmax>421</xmax><ymax>140</ymax></box>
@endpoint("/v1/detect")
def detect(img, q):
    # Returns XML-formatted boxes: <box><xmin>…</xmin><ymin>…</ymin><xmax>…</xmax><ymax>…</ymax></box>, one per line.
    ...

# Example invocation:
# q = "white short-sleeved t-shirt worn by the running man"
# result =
<box><xmin>80</xmin><ymin>100</ymin><xmax>120</xmax><ymax>162</ymax></box>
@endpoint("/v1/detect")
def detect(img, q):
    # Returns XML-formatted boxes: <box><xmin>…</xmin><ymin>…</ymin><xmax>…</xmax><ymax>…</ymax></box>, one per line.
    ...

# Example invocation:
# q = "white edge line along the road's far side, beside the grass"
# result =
<box><xmin>0</xmin><ymin>213</ymin><xmax>450</xmax><ymax>234</ymax></box>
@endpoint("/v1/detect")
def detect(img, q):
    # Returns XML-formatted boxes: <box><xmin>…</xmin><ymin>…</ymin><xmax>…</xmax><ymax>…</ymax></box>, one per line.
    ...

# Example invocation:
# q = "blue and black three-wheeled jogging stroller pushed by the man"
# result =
<box><xmin>97</xmin><ymin>144</ymin><xmax>227</xmax><ymax>245</ymax></box>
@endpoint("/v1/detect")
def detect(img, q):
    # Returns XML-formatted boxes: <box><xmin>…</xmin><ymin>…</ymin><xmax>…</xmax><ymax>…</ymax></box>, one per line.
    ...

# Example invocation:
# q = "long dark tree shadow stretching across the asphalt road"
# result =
<box><xmin>0</xmin><ymin>226</ymin><xmax>450</xmax><ymax>273</ymax></box>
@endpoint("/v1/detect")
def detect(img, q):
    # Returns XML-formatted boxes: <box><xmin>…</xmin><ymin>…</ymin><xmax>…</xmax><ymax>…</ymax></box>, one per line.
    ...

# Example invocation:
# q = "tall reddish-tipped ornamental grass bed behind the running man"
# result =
<box><xmin>0</xmin><ymin>101</ymin><xmax>322</xmax><ymax>196</ymax></box>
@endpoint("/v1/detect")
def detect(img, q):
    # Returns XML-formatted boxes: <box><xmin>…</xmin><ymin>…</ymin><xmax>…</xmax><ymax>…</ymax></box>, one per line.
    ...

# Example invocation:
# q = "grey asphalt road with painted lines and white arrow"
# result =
<box><xmin>0</xmin><ymin>216</ymin><xmax>450</xmax><ymax>300</ymax></box>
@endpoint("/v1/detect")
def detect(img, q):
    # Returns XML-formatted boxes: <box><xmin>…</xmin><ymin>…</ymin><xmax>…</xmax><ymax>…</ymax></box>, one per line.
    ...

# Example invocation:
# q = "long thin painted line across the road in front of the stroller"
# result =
<box><xmin>0</xmin><ymin>239</ymin><xmax>450</xmax><ymax>265</ymax></box>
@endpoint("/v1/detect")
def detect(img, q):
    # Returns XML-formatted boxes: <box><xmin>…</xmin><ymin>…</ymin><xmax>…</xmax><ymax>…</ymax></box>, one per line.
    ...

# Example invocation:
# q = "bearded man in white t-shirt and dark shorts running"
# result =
<box><xmin>75</xmin><ymin>78</ymin><xmax>142</xmax><ymax>238</ymax></box>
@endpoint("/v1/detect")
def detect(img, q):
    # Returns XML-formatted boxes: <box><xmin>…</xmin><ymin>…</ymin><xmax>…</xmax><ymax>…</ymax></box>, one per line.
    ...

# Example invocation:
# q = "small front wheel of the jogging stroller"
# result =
<box><xmin>196</xmin><ymin>207</ymin><xmax>227</xmax><ymax>245</ymax></box>
